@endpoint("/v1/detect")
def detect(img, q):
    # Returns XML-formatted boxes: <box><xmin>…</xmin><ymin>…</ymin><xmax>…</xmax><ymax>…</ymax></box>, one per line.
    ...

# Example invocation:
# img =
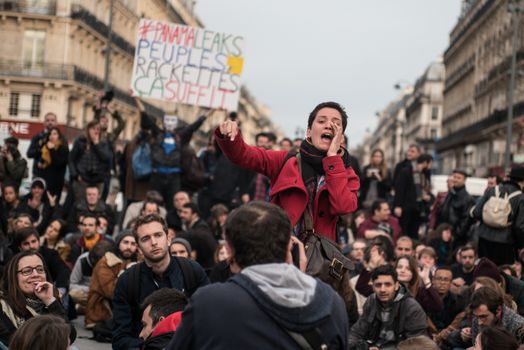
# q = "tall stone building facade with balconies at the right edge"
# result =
<box><xmin>437</xmin><ymin>0</ymin><xmax>524</xmax><ymax>176</ymax></box>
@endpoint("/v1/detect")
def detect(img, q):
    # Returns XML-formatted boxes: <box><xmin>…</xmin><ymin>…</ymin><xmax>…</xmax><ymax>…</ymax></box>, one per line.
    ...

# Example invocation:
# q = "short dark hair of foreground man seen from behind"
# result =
<box><xmin>226</xmin><ymin>201</ymin><xmax>291</xmax><ymax>268</ymax></box>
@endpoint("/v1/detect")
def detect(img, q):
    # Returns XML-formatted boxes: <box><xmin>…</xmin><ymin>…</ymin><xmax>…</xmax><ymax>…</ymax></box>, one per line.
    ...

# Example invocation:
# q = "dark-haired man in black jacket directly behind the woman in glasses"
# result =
<box><xmin>15</xmin><ymin>227</ymin><xmax>71</xmax><ymax>295</ymax></box>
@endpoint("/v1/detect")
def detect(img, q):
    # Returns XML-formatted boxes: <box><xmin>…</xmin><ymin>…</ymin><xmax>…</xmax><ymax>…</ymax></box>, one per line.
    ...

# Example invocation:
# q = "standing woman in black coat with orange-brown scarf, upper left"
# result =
<box><xmin>35</xmin><ymin>127</ymin><xmax>69</xmax><ymax>200</ymax></box>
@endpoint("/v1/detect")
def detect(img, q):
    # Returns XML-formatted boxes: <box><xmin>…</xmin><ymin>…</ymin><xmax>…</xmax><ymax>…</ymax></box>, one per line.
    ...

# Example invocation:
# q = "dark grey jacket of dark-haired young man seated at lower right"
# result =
<box><xmin>349</xmin><ymin>285</ymin><xmax>427</xmax><ymax>349</ymax></box>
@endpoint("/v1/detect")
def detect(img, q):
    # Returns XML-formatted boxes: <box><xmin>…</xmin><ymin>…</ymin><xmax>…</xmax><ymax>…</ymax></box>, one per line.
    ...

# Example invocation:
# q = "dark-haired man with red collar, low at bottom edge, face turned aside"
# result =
<box><xmin>140</xmin><ymin>288</ymin><xmax>188</xmax><ymax>350</ymax></box>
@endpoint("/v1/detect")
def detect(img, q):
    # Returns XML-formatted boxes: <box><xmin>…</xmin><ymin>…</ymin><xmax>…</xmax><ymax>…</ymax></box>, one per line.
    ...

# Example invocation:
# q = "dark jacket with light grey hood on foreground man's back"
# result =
<box><xmin>167</xmin><ymin>263</ymin><xmax>348</xmax><ymax>350</ymax></box>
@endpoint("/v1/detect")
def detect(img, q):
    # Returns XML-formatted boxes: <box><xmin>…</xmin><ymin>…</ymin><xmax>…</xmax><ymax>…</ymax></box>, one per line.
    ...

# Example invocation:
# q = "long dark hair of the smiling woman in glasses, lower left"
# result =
<box><xmin>0</xmin><ymin>251</ymin><xmax>54</xmax><ymax>318</ymax></box>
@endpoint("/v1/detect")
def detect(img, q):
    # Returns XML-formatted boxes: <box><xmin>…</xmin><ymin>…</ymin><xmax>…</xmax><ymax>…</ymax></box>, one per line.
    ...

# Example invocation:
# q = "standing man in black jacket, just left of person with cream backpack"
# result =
<box><xmin>437</xmin><ymin>169</ymin><xmax>475</xmax><ymax>248</ymax></box>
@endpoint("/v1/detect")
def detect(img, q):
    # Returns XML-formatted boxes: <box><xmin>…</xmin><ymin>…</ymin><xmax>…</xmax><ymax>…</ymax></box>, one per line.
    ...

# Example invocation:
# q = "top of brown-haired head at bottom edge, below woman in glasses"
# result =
<box><xmin>9</xmin><ymin>315</ymin><xmax>70</xmax><ymax>350</ymax></box>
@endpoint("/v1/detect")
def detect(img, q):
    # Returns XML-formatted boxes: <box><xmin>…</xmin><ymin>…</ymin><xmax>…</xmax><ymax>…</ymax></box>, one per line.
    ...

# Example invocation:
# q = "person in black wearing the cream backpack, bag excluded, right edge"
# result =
<box><xmin>471</xmin><ymin>166</ymin><xmax>524</xmax><ymax>265</ymax></box>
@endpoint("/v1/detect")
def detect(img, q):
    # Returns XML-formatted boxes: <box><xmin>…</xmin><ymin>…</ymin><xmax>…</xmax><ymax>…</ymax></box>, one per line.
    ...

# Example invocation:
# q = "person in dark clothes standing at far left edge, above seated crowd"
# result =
<box><xmin>0</xmin><ymin>137</ymin><xmax>27</xmax><ymax>191</ymax></box>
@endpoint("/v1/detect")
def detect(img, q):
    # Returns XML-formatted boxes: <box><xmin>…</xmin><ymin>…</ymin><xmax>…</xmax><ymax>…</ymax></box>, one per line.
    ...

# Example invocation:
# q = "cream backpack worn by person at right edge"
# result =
<box><xmin>482</xmin><ymin>185</ymin><xmax>522</xmax><ymax>228</ymax></box>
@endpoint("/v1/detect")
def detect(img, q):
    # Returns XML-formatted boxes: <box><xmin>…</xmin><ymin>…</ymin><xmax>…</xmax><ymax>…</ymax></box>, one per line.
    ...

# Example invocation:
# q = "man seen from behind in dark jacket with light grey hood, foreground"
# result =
<box><xmin>166</xmin><ymin>202</ymin><xmax>349</xmax><ymax>350</ymax></box>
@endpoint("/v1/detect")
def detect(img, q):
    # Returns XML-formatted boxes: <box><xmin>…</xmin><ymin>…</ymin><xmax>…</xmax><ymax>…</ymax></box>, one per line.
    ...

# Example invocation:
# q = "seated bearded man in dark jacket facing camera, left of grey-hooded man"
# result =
<box><xmin>112</xmin><ymin>214</ymin><xmax>209</xmax><ymax>350</ymax></box>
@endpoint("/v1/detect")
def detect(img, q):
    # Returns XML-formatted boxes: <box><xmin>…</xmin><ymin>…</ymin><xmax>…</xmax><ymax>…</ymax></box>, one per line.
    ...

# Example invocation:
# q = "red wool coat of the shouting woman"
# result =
<box><xmin>215</xmin><ymin>128</ymin><xmax>360</xmax><ymax>240</ymax></box>
